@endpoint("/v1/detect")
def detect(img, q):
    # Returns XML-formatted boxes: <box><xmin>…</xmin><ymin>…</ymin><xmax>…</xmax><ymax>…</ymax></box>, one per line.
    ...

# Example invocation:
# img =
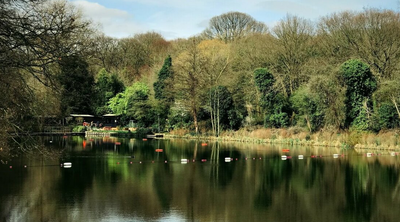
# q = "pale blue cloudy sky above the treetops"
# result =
<box><xmin>69</xmin><ymin>0</ymin><xmax>400</xmax><ymax>40</ymax></box>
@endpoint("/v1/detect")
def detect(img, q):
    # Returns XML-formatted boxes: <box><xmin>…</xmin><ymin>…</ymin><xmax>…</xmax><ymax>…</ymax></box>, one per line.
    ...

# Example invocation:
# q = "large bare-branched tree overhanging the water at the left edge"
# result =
<box><xmin>0</xmin><ymin>0</ymin><xmax>92</xmax><ymax>147</ymax></box>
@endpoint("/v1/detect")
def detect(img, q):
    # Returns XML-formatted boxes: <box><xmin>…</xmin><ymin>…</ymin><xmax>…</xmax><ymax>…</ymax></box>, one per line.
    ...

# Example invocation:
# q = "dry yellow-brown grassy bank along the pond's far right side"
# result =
<box><xmin>166</xmin><ymin>127</ymin><xmax>400</xmax><ymax>150</ymax></box>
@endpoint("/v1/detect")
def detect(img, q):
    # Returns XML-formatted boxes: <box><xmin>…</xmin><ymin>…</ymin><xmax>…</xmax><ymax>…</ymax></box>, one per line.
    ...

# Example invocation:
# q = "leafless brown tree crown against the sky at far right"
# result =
<box><xmin>319</xmin><ymin>9</ymin><xmax>400</xmax><ymax>80</ymax></box>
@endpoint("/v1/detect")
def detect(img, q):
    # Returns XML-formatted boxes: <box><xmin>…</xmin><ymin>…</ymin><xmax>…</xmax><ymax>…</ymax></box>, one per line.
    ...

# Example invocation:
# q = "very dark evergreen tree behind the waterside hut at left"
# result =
<box><xmin>58</xmin><ymin>56</ymin><xmax>94</xmax><ymax>114</ymax></box>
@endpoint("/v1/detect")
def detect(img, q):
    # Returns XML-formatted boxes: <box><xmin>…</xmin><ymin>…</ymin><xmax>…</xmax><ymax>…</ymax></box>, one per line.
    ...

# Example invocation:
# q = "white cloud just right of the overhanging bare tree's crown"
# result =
<box><xmin>72</xmin><ymin>1</ymin><xmax>145</xmax><ymax>38</ymax></box>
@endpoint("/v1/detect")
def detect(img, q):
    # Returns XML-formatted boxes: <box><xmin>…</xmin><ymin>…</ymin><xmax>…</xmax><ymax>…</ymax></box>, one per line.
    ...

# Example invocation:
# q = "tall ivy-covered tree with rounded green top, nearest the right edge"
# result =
<box><xmin>340</xmin><ymin>59</ymin><xmax>377</xmax><ymax>128</ymax></box>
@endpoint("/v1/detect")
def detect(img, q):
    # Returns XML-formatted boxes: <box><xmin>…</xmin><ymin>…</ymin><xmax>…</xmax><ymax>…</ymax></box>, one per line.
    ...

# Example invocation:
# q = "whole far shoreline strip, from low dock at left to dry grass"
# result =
<box><xmin>10</xmin><ymin>128</ymin><xmax>400</xmax><ymax>151</ymax></box>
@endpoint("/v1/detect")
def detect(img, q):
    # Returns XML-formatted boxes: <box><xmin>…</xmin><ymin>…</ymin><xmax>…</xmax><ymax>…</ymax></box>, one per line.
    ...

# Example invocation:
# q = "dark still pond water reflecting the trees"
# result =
<box><xmin>0</xmin><ymin>137</ymin><xmax>400</xmax><ymax>222</ymax></box>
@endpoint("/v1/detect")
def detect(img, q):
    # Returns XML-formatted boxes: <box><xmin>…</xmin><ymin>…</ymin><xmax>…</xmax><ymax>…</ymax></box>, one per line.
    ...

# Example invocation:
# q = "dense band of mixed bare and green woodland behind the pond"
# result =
<box><xmin>0</xmin><ymin>0</ymin><xmax>400</xmax><ymax>146</ymax></box>
